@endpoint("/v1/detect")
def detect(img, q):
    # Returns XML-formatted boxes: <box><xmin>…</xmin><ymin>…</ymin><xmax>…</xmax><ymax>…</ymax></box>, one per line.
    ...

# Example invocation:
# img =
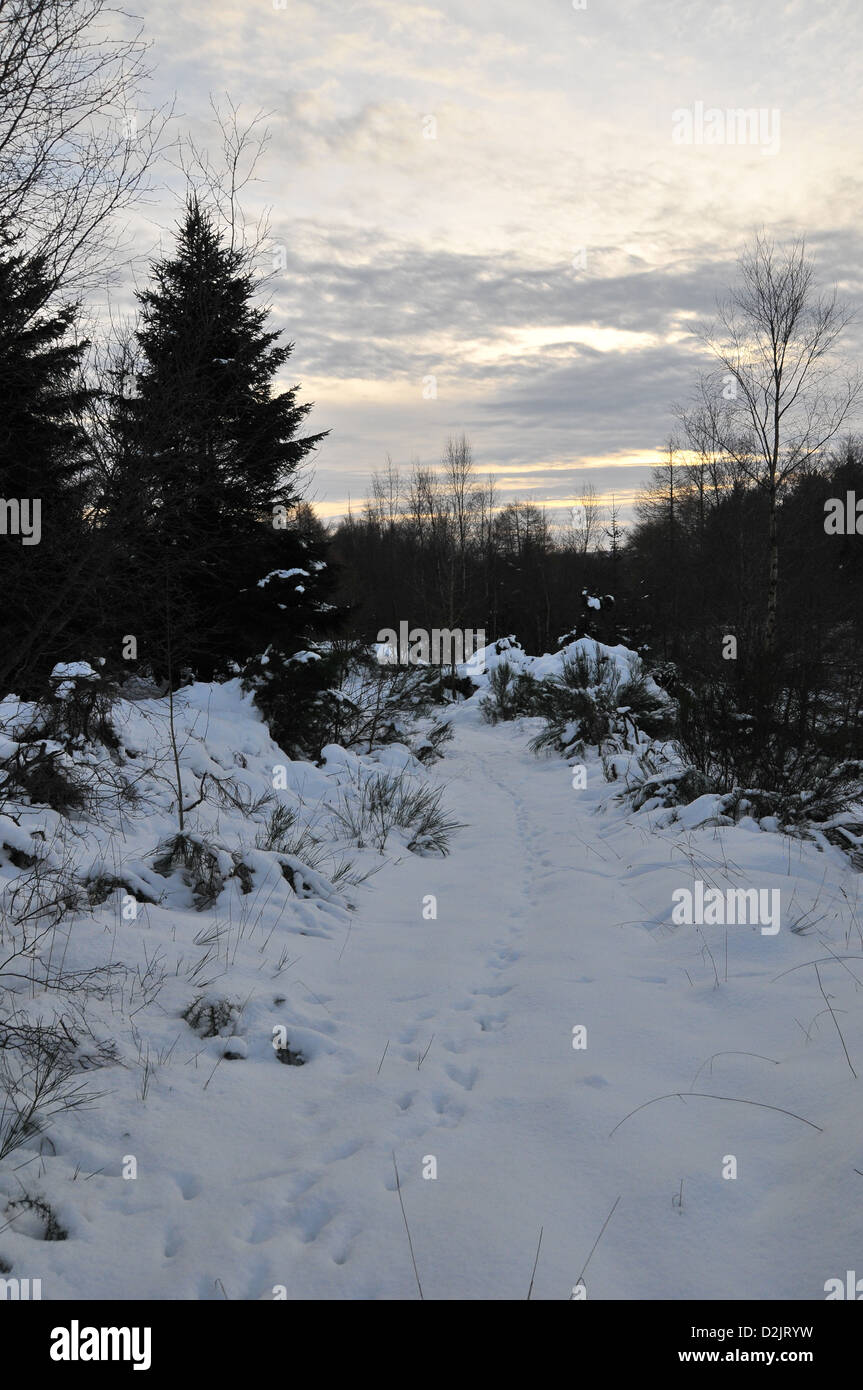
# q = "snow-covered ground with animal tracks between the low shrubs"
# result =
<box><xmin>0</xmin><ymin>682</ymin><xmax>863</xmax><ymax>1300</ymax></box>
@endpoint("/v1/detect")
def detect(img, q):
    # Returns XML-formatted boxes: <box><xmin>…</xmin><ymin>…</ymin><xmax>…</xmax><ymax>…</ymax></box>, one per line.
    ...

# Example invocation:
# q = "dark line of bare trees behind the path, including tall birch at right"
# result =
<box><xmin>327</xmin><ymin>235</ymin><xmax>863</xmax><ymax>784</ymax></box>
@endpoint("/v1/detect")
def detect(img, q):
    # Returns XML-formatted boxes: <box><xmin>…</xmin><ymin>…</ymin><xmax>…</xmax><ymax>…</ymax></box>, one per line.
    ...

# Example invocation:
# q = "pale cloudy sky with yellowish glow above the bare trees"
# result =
<box><xmin>120</xmin><ymin>0</ymin><xmax>863</xmax><ymax>516</ymax></box>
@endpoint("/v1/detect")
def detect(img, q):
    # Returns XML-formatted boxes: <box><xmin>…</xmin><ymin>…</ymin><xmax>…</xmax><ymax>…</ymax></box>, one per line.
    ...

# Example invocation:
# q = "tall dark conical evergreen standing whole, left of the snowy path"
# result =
<box><xmin>104</xmin><ymin>200</ymin><xmax>324</xmax><ymax>680</ymax></box>
